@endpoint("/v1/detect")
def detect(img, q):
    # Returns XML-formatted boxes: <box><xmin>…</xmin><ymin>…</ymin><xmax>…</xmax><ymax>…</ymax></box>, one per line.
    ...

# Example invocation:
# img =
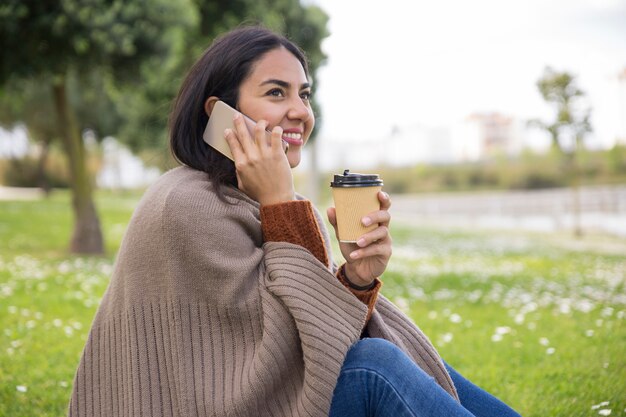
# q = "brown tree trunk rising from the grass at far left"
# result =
<box><xmin>52</xmin><ymin>75</ymin><xmax>104</xmax><ymax>254</ymax></box>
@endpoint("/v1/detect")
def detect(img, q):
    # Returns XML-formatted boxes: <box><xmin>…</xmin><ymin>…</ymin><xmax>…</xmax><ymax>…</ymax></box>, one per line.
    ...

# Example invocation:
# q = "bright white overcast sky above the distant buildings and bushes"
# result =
<box><xmin>310</xmin><ymin>0</ymin><xmax>626</xmax><ymax>148</ymax></box>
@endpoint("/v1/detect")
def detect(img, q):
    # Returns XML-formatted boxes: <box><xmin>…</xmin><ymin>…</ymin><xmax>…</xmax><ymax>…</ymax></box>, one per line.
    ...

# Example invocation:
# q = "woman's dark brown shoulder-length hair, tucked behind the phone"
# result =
<box><xmin>169</xmin><ymin>26</ymin><xmax>308</xmax><ymax>192</ymax></box>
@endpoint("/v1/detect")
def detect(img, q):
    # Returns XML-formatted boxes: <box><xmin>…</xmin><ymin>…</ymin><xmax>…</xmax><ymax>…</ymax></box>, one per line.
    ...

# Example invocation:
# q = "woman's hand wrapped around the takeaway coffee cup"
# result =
<box><xmin>327</xmin><ymin>191</ymin><xmax>392</xmax><ymax>286</ymax></box>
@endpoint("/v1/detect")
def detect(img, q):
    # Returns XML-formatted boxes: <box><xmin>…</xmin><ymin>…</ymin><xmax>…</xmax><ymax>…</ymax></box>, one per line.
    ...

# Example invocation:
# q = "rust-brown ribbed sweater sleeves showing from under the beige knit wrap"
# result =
<box><xmin>261</xmin><ymin>200</ymin><xmax>382</xmax><ymax>321</ymax></box>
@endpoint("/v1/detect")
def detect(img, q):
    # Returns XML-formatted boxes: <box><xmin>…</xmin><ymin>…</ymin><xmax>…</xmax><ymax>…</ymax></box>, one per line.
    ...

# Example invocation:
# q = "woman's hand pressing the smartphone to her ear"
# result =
<box><xmin>224</xmin><ymin>113</ymin><xmax>295</xmax><ymax>205</ymax></box>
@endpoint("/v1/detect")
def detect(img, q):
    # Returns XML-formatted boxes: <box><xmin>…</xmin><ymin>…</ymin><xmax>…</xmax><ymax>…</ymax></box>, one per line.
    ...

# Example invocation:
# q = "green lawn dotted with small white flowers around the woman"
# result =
<box><xmin>0</xmin><ymin>193</ymin><xmax>626</xmax><ymax>416</ymax></box>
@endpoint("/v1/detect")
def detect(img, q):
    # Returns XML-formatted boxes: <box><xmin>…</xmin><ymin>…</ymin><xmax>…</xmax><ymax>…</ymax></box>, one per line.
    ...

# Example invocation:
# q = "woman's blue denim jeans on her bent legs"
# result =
<box><xmin>330</xmin><ymin>338</ymin><xmax>519</xmax><ymax>417</ymax></box>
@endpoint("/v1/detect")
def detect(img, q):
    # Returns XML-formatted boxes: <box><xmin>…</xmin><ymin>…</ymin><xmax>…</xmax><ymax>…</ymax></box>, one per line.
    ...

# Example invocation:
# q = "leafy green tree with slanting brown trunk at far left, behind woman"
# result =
<box><xmin>0</xmin><ymin>0</ymin><xmax>190</xmax><ymax>253</ymax></box>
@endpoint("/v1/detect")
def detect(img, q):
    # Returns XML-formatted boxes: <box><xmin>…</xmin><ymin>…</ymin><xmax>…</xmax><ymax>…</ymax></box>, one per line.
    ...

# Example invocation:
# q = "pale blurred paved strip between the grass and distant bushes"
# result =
<box><xmin>392</xmin><ymin>186</ymin><xmax>626</xmax><ymax>237</ymax></box>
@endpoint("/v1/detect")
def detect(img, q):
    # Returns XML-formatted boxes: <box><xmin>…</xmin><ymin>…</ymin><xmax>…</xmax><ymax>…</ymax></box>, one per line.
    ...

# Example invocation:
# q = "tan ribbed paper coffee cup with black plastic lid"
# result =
<box><xmin>330</xmin><ymin>169</ymin><xmax>383</xmax><ymax>243</ymax></box>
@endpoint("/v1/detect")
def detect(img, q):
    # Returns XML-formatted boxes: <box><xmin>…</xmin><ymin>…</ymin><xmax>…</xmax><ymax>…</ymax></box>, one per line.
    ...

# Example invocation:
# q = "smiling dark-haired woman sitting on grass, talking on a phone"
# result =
<box><xmin>69</xmin><ymin>27</ymin><xmax>516</xmax><ymax>416</ymax></box>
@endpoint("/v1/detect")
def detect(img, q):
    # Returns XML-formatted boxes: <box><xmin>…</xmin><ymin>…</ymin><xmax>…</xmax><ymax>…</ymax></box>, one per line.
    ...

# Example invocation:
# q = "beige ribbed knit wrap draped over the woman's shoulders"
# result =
<box><xmin>69</xmin><ymin>167</ymin><xmax>457</xmax><ymax>417</ymax></box>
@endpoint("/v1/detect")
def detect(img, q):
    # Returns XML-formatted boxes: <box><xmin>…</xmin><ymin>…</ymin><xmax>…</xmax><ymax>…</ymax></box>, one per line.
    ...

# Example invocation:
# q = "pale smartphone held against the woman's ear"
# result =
<box><xmin>202</xmin><ymin>100</ymin><xmax>289</xmax><ymax>161</ymax></box>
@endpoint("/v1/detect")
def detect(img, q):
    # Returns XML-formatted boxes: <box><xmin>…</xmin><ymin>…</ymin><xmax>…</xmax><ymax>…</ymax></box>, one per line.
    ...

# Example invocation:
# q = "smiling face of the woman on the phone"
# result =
<box><xmin>237</xmin><ymin>47</ymin><xmax>315</xmax><ymax>168</ymax></box>
